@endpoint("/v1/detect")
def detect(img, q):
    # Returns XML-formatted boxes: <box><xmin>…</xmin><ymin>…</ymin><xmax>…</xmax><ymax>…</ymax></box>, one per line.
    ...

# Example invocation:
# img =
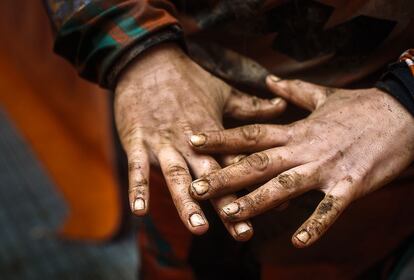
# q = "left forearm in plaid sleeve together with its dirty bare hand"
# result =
<box><xmin>42</xmin><ymin>0</ymin><xmax>286</xmax><ymax>240</ymax></box>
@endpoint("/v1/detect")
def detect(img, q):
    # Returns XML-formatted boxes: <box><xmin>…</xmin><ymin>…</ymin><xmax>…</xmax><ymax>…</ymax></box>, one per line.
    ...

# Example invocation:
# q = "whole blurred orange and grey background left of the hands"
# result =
<box><xmin>0</xmin><ymin>0</ymin><xmax>139</xmax><ymax>279</ymax></box>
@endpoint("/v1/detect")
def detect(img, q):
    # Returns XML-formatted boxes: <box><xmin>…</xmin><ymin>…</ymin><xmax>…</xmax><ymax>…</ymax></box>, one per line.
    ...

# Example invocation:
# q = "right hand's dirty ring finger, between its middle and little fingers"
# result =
<box><xmin>220</xmin><ymin>163</ymin><xmax>320</xmax><ymax>221</ymax></box>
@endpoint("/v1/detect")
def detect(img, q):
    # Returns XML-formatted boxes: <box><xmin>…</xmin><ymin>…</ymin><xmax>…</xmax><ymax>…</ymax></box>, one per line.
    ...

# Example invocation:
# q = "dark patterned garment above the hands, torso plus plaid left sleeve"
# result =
<box><xmin>45</xmin><ymin>0</ymin><xmax>414</xmax><ymax>87</ymax></box>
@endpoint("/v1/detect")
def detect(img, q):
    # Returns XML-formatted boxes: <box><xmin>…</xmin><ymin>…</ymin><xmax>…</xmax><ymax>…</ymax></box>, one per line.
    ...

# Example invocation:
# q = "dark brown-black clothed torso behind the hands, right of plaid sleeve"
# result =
<box><xmin>177</xmin><ymin>0</ymin><xmax>414</xmax><ymax>86</ymax></box>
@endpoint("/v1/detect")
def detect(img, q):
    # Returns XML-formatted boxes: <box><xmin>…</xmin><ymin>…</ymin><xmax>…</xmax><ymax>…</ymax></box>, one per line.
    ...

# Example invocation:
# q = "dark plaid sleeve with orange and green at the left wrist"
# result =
<box><xmin>45</xmin><ymin>0</ymin><xmax>182</xmax><ymax>88</ymax></box>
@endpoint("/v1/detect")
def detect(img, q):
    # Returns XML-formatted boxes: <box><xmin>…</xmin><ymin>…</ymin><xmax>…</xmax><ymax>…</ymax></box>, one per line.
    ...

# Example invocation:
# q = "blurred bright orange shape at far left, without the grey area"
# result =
<box><xmin>0</xmin><ymin>0</ymin><xmax>121</xmax><ymax>240</ymax></box>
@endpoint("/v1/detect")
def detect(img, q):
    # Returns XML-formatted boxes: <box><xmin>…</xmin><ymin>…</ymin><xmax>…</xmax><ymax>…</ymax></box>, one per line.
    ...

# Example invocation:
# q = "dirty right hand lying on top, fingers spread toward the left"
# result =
<box><xmin>190</xmin><ymin>76</ymin><xmax>414</xmax><ymax>248</ymax></box>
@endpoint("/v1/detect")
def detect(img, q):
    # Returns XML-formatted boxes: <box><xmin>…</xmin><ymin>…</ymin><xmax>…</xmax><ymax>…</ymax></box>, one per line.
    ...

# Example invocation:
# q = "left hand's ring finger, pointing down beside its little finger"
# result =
<box><xmin>158</xmin><ymin>147</ymin><xmax>208</xmax><ymax>234</ymax></box>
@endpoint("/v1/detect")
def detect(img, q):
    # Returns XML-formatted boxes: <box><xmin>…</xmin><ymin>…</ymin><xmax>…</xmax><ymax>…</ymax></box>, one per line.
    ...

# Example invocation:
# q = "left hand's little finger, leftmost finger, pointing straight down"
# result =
<box><xmin>125</xmin><ymin>139</ymin><xmax>150</xmax><ymax>216</ymax></box>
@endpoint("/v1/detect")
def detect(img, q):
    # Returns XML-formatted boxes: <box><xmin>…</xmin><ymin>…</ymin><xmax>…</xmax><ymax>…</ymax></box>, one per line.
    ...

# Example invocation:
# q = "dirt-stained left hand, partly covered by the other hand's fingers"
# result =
<box><xmin>114</xmin><ymin>44</ymin><xmax>286</xmax><ymax>241</ymax></box>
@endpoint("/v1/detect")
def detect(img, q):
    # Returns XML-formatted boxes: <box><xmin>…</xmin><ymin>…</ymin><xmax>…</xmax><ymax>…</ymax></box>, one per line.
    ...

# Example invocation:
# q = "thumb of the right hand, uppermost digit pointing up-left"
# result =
<box><xmin>266</xmin><ymin>75</ymin><xmax>328</xmax><ymax>111</ymax></box>
